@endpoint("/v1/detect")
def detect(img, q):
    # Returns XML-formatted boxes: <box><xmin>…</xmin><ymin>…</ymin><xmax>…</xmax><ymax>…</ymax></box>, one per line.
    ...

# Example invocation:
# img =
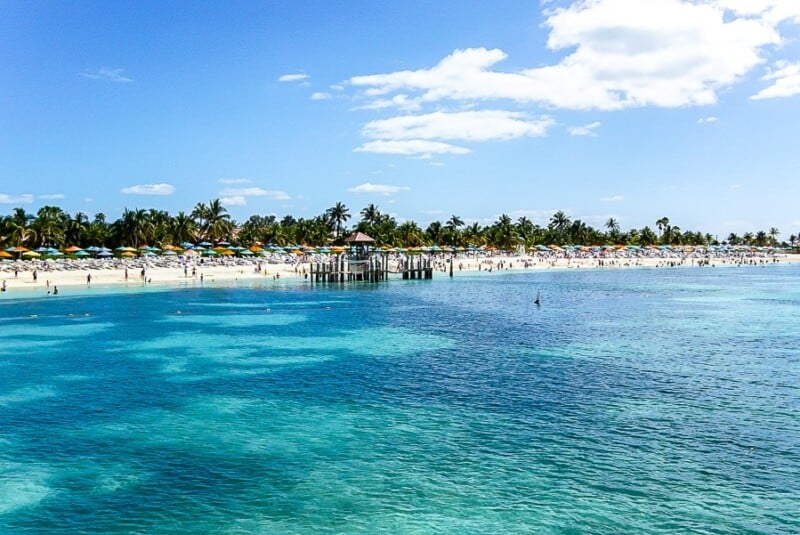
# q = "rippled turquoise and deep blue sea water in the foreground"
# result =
<box><xmin>0</xmin><ymin>266</ymin><xmax>800</xmax><ymax>534</ymax></box>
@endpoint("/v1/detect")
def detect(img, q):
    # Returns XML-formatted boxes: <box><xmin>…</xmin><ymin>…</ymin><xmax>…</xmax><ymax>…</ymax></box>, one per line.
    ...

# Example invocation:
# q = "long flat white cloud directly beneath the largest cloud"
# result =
<box><xmin>361</xmin><ymin>110</ymin><xmax>555</xmax><ymax>141</ymax></box>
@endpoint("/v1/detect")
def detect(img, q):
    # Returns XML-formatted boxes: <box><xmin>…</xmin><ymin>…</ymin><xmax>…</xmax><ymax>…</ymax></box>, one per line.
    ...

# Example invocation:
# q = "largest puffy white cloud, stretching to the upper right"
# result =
<box><xmin>349</xmin><ymin>0</ymin><xmax>798</xmax><ymax>110</ymax></box>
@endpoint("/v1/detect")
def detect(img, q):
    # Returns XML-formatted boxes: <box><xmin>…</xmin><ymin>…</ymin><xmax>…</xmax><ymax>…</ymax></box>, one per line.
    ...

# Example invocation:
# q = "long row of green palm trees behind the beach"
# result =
<box><xmin>0</xmin><ymin>199</ymin><xmax>800</xmax><ymax>250</ymax></box>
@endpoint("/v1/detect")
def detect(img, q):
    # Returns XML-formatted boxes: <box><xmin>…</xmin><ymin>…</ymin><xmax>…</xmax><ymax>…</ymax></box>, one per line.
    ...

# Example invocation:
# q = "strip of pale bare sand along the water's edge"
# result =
<box><xmin>0</xmin><ymin>254</ymin><xmax>800</xmax><ymax>294</ymax></box>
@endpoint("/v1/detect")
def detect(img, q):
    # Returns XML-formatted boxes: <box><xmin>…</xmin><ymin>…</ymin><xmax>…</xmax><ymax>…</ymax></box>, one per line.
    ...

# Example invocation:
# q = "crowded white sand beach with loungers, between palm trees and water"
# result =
<box><xmin>0</xmin><ymin>251</ymin><xmax>800</xmax><ymax>293</ymax></box>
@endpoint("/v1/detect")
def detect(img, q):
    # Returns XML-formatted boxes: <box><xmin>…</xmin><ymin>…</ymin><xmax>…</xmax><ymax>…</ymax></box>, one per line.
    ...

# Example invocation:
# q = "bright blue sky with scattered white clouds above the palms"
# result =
<box><xmin>0</xmin><ymin>0</ymin><xmax>800</xmax><ymax>239</ymax></box>
